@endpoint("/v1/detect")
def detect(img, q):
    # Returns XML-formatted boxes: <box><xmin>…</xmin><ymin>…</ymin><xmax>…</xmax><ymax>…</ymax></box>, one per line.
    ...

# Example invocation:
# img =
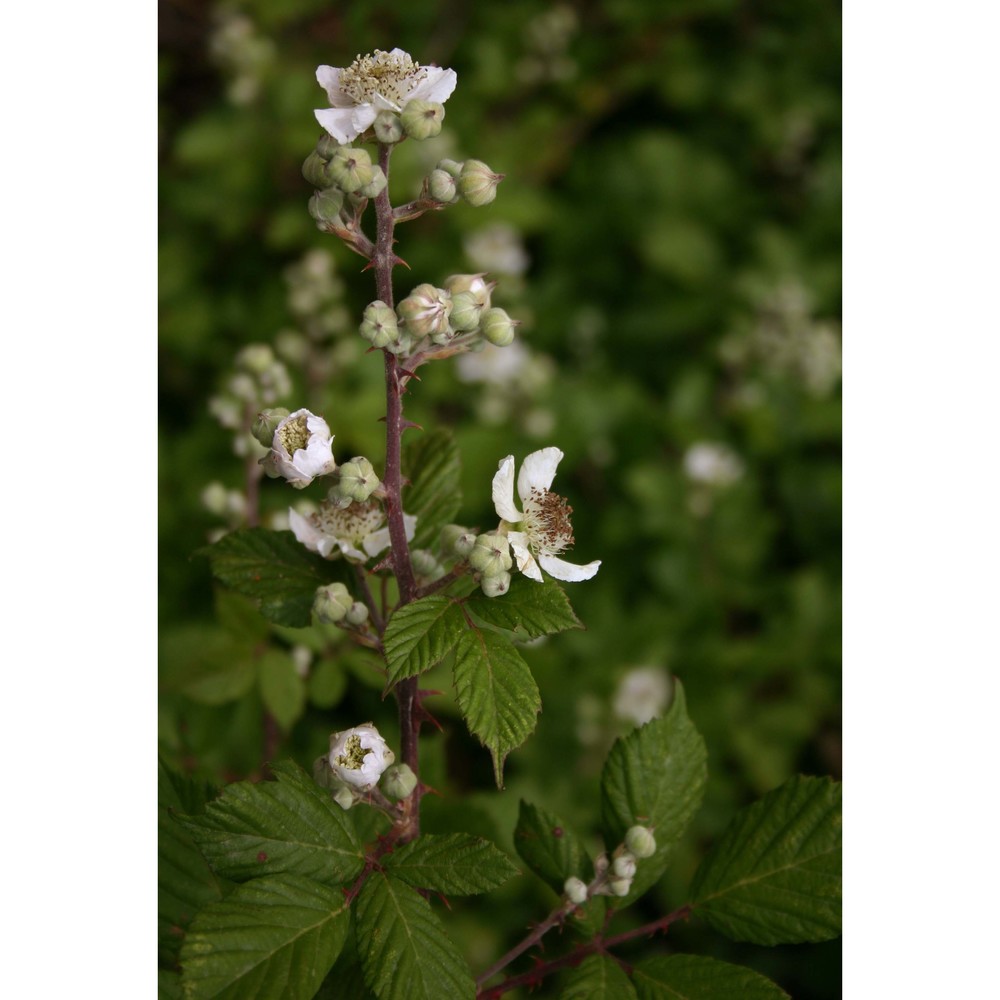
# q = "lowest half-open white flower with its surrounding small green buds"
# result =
<box><xmin>313</xmin><ymin>722</ymin><xmax>417</xmax><ymax>809</ymax></box>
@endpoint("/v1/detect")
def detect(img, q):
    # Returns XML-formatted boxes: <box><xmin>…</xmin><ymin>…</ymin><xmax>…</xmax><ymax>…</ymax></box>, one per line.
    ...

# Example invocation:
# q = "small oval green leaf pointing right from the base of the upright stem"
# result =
<box><xmin>385</xmin><ymin>833</ymin><xmax>520</xmax><ymax>896</ymax></box>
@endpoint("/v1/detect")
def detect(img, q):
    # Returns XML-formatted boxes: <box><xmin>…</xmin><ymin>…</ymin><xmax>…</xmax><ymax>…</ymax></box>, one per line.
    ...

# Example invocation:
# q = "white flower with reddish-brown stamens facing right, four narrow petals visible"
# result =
<box><xmin>493</xmin><ymin>448</ymin><xmax>601</xmax><ymax>583</ymax></box>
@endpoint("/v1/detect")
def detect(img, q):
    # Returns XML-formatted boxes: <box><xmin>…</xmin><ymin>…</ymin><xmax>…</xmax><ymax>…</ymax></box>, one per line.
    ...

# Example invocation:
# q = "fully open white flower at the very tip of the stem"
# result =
<box><xmin>316</xmin><ymin>49</ymin><xmax>458</xmax><ymax>143</ymax></box>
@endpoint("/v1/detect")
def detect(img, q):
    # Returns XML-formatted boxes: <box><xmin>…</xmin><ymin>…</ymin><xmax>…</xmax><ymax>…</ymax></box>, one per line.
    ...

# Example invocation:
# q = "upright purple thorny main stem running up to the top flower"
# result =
<box><xmin>372</xmin><ymin>143</ymin><xmax>421</xmax><ymax>842</ymax></box>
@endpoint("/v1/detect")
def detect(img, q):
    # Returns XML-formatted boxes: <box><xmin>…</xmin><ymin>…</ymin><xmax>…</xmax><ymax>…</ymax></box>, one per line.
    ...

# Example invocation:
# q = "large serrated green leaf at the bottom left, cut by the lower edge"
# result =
<box><xmin>181</xmin><ymin>875</ymin><xmax>350</xmax><ymax>1000</ymax></box>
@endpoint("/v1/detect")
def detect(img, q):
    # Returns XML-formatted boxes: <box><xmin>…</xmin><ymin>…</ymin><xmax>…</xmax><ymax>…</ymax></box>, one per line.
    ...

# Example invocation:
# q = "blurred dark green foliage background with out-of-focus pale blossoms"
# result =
<box><xmin>160</xmin><ymin>0</ymin><xmax>840</xmax><ymax>998</ymax></box>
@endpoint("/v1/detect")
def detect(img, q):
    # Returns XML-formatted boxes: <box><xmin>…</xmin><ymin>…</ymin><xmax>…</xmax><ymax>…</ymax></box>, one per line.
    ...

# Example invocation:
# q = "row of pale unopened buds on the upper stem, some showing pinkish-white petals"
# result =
<box><xmin>360</xmin><ymin>274</ymin><xmax>517</xmax><ymax>357</ymax></box>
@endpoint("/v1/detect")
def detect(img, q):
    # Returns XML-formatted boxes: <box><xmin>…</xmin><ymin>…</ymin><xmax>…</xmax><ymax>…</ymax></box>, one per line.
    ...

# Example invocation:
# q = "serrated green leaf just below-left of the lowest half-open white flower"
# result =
<box><xmin>184</xmin><ymin>761</ymin><xmax>364</xmax><ymax>885</ymax></box>
